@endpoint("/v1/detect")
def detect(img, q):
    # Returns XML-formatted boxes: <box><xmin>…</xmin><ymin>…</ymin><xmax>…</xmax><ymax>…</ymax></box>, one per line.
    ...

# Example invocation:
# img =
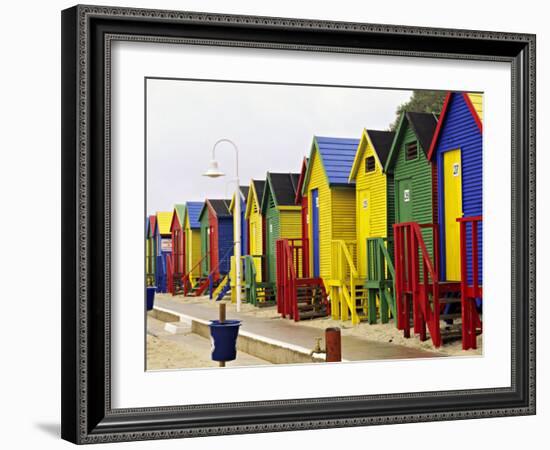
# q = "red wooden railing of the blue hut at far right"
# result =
<box><xmin>456</xmin><ymin>216</ymin><xmax>483</xmax><ymax>350</ymax></box>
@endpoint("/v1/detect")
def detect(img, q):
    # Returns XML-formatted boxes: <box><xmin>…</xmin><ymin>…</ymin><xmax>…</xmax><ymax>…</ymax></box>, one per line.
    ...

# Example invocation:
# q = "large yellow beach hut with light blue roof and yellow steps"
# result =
<box><xmin>302</xmin><ymin>136</ymin><xmax>363</xmax><ymax>323</ymax></box>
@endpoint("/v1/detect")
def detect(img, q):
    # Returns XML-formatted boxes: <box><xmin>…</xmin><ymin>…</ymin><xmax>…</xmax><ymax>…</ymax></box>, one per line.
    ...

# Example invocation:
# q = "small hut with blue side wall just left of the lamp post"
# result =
<box><xmin>199</xmin><ymin>199</ymin><xmax>233</xmax><ymax>282</ymax></box>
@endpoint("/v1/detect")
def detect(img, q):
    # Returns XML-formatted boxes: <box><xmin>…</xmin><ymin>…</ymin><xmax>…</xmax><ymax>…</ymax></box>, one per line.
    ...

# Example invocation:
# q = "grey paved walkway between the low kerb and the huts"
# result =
<box><xmin>155</xmin><ymin>297</ymin><xmax>444</xmax><ymax>361</ymax></box>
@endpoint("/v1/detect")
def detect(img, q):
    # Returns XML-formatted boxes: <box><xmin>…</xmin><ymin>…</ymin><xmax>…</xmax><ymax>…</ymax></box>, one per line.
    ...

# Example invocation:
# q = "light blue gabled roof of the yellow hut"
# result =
<box><xmin>302</xmin><ymin>136</ymin><xmax>359</xmax><ymax>192</ymax></box>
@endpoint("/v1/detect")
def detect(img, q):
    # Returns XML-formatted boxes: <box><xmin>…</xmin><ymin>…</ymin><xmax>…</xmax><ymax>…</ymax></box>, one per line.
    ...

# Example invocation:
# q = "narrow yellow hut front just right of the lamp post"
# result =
<box><xmin>245</xmin><ymin>180</ymin><xmax>265</xmax><ymax>282</ymax></box>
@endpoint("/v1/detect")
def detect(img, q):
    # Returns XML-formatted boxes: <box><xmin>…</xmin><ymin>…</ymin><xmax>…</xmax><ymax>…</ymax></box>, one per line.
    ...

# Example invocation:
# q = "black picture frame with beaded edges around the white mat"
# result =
<box><xmin>61</xmin><ymin>5</ymin><xmax>535</xmax><ymax>444</ymax></box>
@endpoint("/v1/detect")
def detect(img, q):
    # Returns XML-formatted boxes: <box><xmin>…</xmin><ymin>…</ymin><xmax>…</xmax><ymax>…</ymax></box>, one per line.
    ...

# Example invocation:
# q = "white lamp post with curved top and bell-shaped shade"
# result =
<box><xmin>203</xmin><ymin>138</ymin><xmax>241</xmax><ymax>312</ymax></box>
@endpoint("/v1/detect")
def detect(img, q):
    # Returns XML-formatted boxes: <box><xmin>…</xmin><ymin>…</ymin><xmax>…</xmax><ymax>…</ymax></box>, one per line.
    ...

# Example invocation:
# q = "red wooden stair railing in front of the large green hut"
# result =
<box><xmin>393</xmin><ymin>222</ymin><xmax>441</xmax><ymax>347</ymax></box>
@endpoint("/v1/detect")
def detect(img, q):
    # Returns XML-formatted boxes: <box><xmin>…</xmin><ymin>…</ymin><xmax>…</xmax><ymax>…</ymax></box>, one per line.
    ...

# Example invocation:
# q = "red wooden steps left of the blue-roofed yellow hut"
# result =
<box><xmin>276</xmin><ymin>239</ymin><xmax>330</xmax><ymax>322</ymax></box>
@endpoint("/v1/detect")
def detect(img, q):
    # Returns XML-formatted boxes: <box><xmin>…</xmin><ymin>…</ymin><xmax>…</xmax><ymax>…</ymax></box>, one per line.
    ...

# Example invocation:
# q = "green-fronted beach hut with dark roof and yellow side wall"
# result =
<box><xmin>262</xmin><ymin>172</ymin><xmax>302</xmax><ymax>285</ymax></box>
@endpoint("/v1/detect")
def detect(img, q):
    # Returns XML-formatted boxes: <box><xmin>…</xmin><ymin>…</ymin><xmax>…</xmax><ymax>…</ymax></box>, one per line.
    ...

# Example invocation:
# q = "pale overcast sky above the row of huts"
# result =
<box><xmin>146</xmin><ymin>79</ymin><xmax>412</xmax><ymax>215</ymax></box>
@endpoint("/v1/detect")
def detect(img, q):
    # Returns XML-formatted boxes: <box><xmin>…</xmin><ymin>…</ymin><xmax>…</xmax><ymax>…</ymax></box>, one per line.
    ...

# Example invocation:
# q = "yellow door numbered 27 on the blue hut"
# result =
<box><xmin>443</xmin><ymin>149</ymin><xmax>462</xmax><ymax>281</ymax></box>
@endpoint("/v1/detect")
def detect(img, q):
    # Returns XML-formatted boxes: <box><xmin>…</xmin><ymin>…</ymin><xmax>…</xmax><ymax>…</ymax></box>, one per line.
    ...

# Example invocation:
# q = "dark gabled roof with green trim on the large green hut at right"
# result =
<box><xmin>384</xmin><ymin>111</ymin><xmax>437</xmax><ymax>172</ymax></box>
